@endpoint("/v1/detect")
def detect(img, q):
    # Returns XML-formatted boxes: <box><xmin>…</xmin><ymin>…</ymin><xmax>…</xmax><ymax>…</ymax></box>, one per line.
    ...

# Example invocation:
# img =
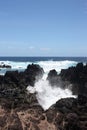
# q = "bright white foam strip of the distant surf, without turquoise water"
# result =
<box><xmin>0</xmin><ymin>60</ymin><xmax>77</xmax><ymax>72</ymax></box>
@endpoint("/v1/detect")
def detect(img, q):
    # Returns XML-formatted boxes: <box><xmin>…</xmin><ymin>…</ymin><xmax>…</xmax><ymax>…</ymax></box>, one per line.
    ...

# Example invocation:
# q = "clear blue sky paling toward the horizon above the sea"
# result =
<box><xmin>0</xmin><ymin>0</ymin><xmax>87</xmax><ymax>56</ymax></box>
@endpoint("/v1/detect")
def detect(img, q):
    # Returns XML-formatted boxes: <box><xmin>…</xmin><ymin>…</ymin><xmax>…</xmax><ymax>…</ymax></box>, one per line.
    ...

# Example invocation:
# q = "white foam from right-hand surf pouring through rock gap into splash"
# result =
<box><xmin>27</xmin><ymin>61</ymin><xmax>77</xmax><ymax>110</ymax></box>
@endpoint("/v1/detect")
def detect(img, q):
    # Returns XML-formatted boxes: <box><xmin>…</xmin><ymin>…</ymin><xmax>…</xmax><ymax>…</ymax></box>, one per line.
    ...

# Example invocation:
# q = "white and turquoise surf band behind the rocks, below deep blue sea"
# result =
<box><xmin>0</xmin><ymin>60</ymin><xmax>77</xmax><ymax>75</ymax></box>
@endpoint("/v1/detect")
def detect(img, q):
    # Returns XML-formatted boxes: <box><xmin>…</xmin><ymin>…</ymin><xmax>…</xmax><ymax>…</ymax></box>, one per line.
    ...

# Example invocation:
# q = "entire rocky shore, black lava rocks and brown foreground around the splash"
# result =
<box><xmin>0</xmin><ymin>63</ymin><xmax>87</xmax><ymax>130</ymax></box>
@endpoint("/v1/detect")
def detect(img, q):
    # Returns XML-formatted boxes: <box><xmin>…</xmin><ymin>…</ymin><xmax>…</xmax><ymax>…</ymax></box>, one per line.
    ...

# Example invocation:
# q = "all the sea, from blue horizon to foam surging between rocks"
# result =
<box><xmin>0</xmin><ymin>57</ymin><xmax>87</xmax><ymax>110</ymax></box>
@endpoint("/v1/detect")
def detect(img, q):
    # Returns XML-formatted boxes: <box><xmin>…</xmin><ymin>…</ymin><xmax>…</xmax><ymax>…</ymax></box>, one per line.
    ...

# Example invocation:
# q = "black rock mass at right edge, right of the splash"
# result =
<box><xmin>60</xmin><ymin>63</ymin><xmax>87</xmax><ymax>96</ymax></box>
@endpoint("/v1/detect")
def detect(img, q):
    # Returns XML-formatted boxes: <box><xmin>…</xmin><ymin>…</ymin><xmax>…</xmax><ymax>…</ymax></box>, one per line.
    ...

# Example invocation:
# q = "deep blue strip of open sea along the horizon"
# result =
<box><xmin>0</xmin><ymin>57</ymin><xmax>87</xmax><ymax>62</ymax></box>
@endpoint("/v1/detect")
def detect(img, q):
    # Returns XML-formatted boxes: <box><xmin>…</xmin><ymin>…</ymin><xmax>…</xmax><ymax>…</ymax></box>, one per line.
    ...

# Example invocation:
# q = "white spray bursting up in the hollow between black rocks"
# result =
<box><xmin>27</xmin><ymin>78</ymin><xmax>76</xmax><ymax>110</ymax></box>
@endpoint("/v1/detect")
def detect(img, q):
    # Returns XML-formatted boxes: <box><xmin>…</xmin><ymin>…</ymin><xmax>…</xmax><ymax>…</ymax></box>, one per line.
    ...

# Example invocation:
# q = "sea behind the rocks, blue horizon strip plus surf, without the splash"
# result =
<box><xmin>0</xmin><ymin>57</ymin><xmax>87</xmax><ymax>75</ymax></box>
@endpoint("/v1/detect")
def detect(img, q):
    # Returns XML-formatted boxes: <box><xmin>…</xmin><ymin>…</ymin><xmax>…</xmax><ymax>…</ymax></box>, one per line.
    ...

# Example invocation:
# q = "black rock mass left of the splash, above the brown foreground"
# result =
<box><xmin>0</xmin><ymin>64</ymin><xmax>44</xmax><ymax>107</ymax></box>
